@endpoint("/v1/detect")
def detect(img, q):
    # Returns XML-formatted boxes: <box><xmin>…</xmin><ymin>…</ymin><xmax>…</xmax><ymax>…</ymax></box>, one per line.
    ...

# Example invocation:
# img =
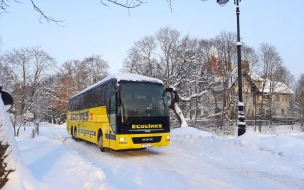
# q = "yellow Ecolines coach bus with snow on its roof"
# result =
<box><xmin>67</xmin><ymin>73</ymin><xmax>176</xmax><ymax>152</ymax></box>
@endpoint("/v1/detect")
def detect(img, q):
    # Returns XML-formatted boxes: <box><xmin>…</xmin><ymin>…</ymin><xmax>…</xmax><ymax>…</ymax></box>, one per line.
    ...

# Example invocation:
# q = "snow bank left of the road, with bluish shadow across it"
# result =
<box><xmin>5</xmin><ymin>122</ymin><xmax>114</xmax><ymax>190</ymax></box>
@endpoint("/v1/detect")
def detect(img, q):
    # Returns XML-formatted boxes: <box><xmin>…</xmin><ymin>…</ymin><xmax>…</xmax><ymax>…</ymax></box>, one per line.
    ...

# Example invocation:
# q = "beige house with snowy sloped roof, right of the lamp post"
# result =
<box><xmin>231</xmin><ymin>65</ymin><xmax>294</xmax><ymax>120</ymax></box>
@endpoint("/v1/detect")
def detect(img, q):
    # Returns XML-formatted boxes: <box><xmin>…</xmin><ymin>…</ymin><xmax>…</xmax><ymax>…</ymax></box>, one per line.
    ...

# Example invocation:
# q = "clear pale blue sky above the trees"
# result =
<box><xmin>0</xmin><ymin>0</ymin><xmax>304</xmax><ymax>78</ymax></box>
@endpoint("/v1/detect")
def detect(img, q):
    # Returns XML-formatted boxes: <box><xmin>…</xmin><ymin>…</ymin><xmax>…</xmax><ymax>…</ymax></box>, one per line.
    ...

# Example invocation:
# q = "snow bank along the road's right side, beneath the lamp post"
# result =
<box><xmin>171</xmin><ymin>127</ymin><xmax>304</xmax><ymax>176</ymax></box>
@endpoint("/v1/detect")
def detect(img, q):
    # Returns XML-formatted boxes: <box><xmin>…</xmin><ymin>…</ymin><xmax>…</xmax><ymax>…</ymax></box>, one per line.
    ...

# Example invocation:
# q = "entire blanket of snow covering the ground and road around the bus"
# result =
<box><xmin>3</xmin><ymin>123</ymin><xmax>304</xmax><ymax>190</ymax></box>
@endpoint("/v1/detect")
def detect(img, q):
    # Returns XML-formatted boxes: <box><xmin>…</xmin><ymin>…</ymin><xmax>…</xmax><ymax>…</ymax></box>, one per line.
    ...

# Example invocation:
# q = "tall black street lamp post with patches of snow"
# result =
<box><xmin>216</xmin><ymin>0</ymin><xmax>246</xmax><ymax>136</ymax></box>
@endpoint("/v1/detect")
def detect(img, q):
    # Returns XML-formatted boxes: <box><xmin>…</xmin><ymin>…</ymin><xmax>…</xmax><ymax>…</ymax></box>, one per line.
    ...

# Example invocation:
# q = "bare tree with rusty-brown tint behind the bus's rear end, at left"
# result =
<box><xmin>38</xmin><ymin>59</ymin><xmax>85</xmax><ymax>123</ymax></box>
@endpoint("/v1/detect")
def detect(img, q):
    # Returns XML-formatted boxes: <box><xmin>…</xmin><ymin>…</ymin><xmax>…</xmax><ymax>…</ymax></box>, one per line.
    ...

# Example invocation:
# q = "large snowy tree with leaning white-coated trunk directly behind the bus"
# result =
<box><xmin>121</xmin><ymin>27</ymin><xmax>221</xmax><ymax>125</ymax></box>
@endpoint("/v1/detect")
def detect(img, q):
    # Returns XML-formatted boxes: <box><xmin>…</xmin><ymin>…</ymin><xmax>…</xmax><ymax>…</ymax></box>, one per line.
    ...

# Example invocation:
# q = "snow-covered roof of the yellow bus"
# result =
<box><xmin>71</xmin><ymin>73</ymin><xmax>163</xmax><ymax>98</ymax></box>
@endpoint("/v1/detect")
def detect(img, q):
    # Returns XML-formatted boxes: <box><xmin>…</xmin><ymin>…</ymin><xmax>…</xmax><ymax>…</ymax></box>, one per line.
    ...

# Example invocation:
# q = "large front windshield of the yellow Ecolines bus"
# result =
<box><xmin>120</xmin><ymin>82</ymin><xmax>168</xmax><ymax>120</ymax></box>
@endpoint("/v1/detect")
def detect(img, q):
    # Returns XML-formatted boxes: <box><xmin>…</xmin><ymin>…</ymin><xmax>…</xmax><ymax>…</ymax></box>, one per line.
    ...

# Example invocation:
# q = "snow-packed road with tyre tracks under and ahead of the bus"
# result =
<box><xmin>66</xmin><ymin>131</ymin><xmax>304</xmax><ymax>189</ymax></box>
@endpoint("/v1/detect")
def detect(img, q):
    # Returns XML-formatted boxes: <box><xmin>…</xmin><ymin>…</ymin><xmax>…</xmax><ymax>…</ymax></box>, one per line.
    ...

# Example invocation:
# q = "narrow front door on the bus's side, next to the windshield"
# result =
<box><xmin>108</xmin><ymin>93</ymin><xmax>116</xmax><ymax>149</ymax></box>
